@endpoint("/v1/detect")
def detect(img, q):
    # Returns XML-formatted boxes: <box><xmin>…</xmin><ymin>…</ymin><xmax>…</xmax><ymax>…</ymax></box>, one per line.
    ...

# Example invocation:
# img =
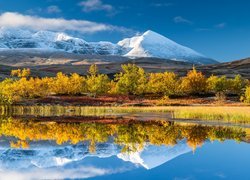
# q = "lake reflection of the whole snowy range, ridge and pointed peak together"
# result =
<box><xmin>0</xmin><ymin>139</ymin><xmax>192</xmax><ymax>170</ymax></box>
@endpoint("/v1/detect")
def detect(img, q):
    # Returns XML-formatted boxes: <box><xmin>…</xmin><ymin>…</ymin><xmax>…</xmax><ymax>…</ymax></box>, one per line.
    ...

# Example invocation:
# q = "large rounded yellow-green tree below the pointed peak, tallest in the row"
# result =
<box><xmin>115</xmin><ymin>64</ymin><xmax>147</xmax><ymax>95</ymax></box>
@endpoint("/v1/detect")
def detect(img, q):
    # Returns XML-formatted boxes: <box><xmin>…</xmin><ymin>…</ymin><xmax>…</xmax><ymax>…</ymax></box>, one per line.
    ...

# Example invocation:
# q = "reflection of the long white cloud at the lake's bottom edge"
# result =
<box><xmin>0</xmin><ymin>163</ymin><xmax>136</xmax><ymax>180</ymax></box>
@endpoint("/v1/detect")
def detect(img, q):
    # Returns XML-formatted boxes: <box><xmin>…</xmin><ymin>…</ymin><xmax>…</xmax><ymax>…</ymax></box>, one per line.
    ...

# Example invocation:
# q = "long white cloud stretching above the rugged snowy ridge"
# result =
<box><xmin>0</xmin><ymin>12</ymin><xmax>132</xmax><ymax>33</ymax></box>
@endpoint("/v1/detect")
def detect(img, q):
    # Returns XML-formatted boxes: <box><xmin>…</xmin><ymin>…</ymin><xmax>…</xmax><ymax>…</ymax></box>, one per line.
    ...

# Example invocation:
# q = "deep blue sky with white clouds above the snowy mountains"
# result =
<box><xmin>0</xmin><ymin>0</ymin><xmax>250</xmax><ymax>61</ymax></box>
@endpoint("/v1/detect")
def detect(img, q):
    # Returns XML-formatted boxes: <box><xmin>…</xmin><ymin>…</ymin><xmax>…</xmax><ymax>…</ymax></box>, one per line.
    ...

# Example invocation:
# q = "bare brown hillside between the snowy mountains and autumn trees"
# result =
<box><xmin>0</xmin><ymin>49</ymin><xmax>250</xmax><ymax>79</ymax></box>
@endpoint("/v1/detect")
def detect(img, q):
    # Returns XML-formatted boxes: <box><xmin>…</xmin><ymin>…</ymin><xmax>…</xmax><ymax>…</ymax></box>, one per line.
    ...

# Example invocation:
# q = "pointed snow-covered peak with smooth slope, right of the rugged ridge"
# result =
<box><xmin>118</xmin><ymin>30</ymin><xmax>216</xmax><ymax>64</ymax></box>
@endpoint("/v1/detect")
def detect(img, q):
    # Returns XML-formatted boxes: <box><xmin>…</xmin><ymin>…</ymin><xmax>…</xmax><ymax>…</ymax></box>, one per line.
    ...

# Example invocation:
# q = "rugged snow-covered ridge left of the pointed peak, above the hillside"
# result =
<box><xmin>0</xmin><ymin>27</ymin><xmax>123</xmax><ymax>55</ymax></box>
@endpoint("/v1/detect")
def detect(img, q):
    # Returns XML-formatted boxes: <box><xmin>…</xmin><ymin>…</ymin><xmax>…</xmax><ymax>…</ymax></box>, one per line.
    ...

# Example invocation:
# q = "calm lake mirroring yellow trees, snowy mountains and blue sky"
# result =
<box><xmin>0</xmin><ymin>105</ymin><xmax>250</xmax><ymax>180</ymax></box>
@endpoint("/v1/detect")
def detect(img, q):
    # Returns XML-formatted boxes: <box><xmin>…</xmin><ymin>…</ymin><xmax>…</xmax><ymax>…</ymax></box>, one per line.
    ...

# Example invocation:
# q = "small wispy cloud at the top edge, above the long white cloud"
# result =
<box><xmin>79</xmin><ymin>0</ymin><xmax>114</xmax><ymax>12</ymax></box>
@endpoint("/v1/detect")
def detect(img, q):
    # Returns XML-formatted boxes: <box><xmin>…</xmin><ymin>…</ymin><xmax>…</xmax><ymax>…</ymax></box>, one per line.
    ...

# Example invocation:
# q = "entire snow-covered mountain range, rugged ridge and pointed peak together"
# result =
<box><xmin>0</xmin><ymin>27</ymin><xmax>217</xmax><ymax>64</ymax></box>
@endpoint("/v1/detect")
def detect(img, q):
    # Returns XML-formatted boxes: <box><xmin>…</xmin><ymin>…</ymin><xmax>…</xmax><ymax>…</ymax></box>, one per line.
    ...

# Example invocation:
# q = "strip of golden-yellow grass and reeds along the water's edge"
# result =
<box><xmin>1</xmin><ymin>105</ymin><xmax>250</xmax><ymax>123</ymax></box>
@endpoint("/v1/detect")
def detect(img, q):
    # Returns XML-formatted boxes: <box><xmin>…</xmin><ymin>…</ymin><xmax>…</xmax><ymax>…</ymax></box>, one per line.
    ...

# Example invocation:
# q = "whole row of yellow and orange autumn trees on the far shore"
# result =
<box><xmin>0</xmin><ymin>64</ymin><xmax>250</xmax><ymax>103</ymax></box>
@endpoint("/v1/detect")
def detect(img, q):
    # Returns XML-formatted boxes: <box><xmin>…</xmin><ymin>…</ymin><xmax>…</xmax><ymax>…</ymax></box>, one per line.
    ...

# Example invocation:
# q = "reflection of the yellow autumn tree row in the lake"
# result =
<box><xmin>0</xmin><ymin>118</ymin><xmax>246</xmax><ymax>152</ymax></box>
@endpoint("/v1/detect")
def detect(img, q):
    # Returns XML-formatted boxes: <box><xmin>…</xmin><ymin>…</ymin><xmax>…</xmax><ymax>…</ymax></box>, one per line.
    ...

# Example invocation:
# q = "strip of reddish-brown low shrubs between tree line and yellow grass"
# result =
<box><xmin>9</xmin><ymin>96</ymin><xmax>250</xmax><ymax>107</ymax></box>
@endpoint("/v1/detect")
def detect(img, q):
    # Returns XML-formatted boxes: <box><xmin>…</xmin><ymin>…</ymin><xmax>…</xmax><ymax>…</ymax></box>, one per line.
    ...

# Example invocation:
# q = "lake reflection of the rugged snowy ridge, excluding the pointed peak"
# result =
<box><xmin>0</xmin><ymin>141</ymin><xmax>119</xmax><ymax>169</ymax></box>
